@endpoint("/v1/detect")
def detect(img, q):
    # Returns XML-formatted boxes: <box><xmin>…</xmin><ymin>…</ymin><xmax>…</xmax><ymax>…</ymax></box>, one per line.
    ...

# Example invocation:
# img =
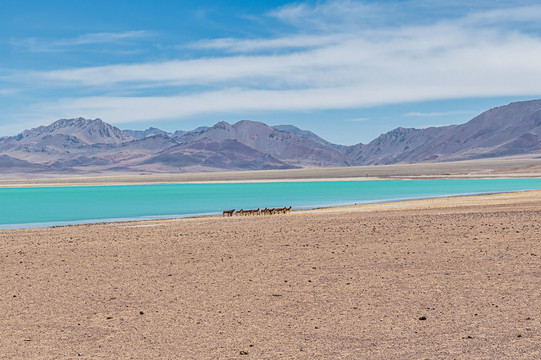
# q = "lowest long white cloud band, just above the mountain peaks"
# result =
<box><xmin>29</xmin><ymin>71</ymin><xmax>541</xmax><ymax>124</ymax></box>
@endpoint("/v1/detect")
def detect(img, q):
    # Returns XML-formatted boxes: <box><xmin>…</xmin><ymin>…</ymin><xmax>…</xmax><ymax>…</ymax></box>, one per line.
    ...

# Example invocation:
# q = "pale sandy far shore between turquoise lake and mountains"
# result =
<box><xmin>0</xmin><ymin>157</ymin><xmax>541</xmax><ymax>187</ymax></box>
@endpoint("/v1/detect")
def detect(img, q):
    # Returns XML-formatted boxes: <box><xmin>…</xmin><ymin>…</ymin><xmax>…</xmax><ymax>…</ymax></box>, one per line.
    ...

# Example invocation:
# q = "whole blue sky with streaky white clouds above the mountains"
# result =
<box><xmin>0</xmin><ymin>0</ymin><xmax>541</xmax><ymax>144</ymax></box>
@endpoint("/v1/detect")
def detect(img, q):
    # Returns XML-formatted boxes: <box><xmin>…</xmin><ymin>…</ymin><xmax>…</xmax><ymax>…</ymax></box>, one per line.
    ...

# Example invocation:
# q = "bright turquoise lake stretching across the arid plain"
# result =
<box><xmin>0</xmin><ymin>179</ymin><xmax>541</xmax><ymax>229</ymax></box>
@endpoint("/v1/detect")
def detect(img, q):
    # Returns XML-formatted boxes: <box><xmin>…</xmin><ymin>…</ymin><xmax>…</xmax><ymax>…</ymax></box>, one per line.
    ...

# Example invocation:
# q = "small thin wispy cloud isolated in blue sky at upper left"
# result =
<box><xmin>10</xmin><ymin>30</ymin><xmax>152</xmax><ymax>52</ymax></box>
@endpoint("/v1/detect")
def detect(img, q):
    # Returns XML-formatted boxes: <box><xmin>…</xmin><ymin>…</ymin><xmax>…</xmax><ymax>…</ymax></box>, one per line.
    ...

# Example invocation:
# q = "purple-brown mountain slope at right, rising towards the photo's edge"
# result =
<box><xmin>344</xmin><ymin>100</ymin><xmax>541</xmax><ymax>165</ymax></box>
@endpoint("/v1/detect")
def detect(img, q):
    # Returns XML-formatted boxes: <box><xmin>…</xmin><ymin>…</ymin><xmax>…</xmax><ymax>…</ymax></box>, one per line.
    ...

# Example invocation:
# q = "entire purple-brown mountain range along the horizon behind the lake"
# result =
<box><xmin>0</xmin><ymin>100</ymin><xmax>541</xmax><ymax>174</ymax></box>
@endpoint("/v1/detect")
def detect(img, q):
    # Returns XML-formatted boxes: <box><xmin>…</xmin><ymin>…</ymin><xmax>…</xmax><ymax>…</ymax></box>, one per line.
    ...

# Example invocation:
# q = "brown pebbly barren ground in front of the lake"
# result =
<box><xmin>0</xmin><ymin>191</ymin><xmax>541</xmax><ymax>359</ymax></box>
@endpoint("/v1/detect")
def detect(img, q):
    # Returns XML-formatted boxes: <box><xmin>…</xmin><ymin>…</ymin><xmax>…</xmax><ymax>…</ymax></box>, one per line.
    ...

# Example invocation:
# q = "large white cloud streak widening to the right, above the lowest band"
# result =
<box><xmin>30</xmin><ymin>25</ymin><xmax>541</xmax><ymax>93</ymax></box>
